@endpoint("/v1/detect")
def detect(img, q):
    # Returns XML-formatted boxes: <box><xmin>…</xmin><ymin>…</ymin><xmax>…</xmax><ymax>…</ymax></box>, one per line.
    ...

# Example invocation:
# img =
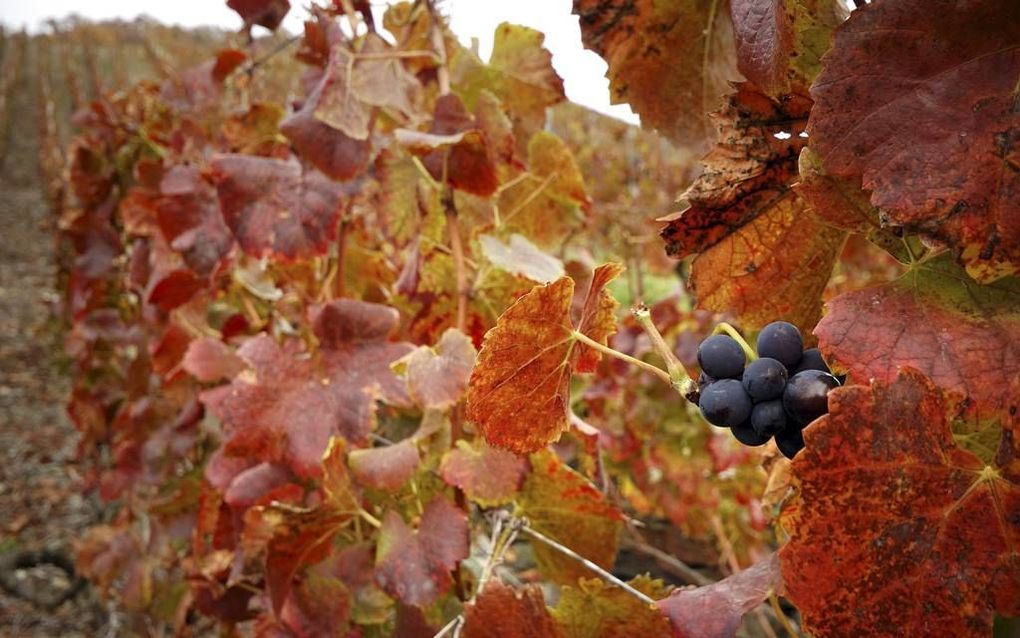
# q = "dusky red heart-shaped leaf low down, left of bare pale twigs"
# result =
<box><xmin>375</xmin><ymin>497</ymin><xmax>468</xmax><ymax>605</ymax></box>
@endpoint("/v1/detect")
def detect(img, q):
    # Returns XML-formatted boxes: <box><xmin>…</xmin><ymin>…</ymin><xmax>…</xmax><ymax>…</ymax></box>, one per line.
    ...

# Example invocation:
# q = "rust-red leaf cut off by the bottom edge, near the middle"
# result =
<box><xmin>461</xmin><ymin>580</ymin><xmax>566</xmax><ymax>638</ymax></box>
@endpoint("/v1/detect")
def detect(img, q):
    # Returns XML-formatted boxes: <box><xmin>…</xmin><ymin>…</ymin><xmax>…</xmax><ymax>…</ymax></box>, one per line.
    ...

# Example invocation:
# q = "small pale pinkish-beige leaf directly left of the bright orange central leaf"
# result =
<box><xmin>399</xmin><ymin>328</ymin><xmax>477</xmax><ymax>409</ymax></box>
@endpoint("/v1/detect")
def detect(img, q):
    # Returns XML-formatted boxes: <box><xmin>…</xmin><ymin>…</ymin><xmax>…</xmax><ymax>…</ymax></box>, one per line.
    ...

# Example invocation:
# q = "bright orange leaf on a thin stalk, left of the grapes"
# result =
<box><xmin>467</xmin><ymin>263</ymin><xmax>622</xmax><ymax>453</ymax></box>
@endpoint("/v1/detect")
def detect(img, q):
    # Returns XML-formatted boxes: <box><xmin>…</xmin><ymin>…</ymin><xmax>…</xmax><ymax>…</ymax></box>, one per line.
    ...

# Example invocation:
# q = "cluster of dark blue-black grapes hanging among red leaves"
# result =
<box><xmin>698</xmin><ymin>322</ymin><xmax>839</xmax><ymax>458</ymax></box>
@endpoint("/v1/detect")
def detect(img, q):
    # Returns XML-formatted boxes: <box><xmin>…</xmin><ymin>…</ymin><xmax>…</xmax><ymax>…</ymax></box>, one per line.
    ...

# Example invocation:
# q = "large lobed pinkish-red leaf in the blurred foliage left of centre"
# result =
<box><xmin>202</xmin><ymin>299</ymin><xmax>411</xmax><ymax>477</ymax></box>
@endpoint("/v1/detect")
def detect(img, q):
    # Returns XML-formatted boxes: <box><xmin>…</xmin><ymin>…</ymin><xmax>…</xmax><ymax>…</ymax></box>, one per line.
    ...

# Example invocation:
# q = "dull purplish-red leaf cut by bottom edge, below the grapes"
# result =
<box><xmin>656</xmin><ymin>554</ymin><xmax>782</xmax><ymax>638</ymax></box>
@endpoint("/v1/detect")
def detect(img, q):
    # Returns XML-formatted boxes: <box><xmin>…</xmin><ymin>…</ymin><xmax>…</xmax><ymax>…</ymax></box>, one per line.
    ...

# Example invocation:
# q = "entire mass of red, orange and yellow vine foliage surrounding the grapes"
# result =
<box><xmin>49</xmin><ymin>0</ymin><xmax>1020</xmax><ymax>638</ymax></box>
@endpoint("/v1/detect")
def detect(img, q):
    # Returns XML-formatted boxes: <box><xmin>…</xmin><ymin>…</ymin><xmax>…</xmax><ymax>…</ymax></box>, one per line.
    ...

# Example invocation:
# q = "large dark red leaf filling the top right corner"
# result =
<box><xmin>808</xmin><ymin>0</ymin><xmax>1020</xmax><ymax>282</ymax></box>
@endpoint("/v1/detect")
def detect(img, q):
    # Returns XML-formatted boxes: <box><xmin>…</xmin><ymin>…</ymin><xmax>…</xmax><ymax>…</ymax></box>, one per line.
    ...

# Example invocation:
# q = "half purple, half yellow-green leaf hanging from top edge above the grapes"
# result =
<box><xmin>730</xmin><ymin>0</ymin><xmax>847</xmax><ymax>97</ymax></box>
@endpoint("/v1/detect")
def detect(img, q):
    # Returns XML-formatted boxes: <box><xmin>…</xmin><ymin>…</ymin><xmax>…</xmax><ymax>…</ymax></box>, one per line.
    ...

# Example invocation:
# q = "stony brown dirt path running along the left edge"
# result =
<box><xmin>0</xmin><ymin>37</ymin><xmax>110</xmax><ymax>638</ymax></box>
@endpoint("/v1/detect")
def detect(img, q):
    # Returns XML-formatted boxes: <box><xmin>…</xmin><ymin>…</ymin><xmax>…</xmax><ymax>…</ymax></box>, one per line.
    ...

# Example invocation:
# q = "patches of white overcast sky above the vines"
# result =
<box><xmin>0</xmin><ymin>0</ymin><xmax>638</xmax><ymax>124</ymax></box>
